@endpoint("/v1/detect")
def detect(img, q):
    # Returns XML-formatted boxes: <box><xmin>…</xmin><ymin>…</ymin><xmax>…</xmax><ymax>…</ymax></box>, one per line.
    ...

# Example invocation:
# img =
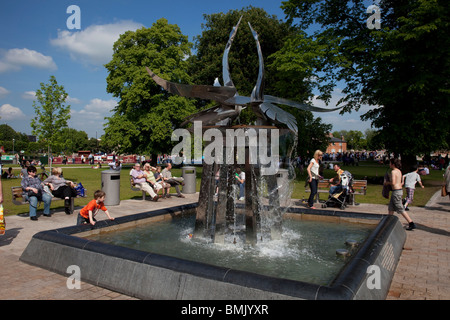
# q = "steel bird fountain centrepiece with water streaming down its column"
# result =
<box><xmin>146</xmin><ymin>17</ymin><xmax>340</xmax><ymax>244</ymax></box>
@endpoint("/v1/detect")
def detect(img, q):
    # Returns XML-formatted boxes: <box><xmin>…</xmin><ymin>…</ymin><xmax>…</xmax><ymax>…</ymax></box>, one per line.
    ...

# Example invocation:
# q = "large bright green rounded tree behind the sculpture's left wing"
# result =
<box><xmin>106</xmin><ymin>19</ymin><xmax>196</xmax><ymax>153</ymax></box>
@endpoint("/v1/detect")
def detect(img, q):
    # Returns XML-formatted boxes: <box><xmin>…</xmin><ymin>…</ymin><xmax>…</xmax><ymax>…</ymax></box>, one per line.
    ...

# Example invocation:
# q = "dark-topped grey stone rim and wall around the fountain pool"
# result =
<box><xmin>20</xmin><ymin>204</ymin><xmax>406</xmax><ymax>300</ymax></box>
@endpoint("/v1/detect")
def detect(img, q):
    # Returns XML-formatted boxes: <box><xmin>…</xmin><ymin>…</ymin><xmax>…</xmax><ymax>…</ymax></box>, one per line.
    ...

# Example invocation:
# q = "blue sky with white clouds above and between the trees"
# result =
<box><xmin>0</xmin><ymin>0</ymin><xmax>370</xmax><ymax>137</ymax></box>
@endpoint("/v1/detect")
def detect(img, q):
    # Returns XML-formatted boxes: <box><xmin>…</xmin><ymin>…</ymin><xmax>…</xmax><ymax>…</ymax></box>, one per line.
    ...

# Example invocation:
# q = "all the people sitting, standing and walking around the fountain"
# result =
<box><xmin>2</xmin><ymin>150</ymin><xmax>450</xmax><ymax>230</ymax></box>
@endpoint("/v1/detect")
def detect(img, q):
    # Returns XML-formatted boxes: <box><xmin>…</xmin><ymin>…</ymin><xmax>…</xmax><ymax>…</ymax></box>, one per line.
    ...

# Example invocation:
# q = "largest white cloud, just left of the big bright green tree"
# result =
<box><xmin>50</xmin><ymin>21</ymin><xmax>142</xmax><ymax>65</ymax></box>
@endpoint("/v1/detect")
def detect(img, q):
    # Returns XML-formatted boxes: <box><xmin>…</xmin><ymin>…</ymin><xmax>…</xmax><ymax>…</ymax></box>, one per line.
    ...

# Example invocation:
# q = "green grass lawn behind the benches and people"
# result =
<box><xmin>2</xmin><ymin>161</ymin><xmax>443</xmax><ymax>215</ymax></box>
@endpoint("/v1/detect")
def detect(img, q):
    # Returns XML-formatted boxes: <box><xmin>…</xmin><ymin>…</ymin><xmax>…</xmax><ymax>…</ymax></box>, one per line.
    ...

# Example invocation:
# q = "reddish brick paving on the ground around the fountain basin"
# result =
<box><xmin>0</xmin><ymin>190</ymin><xmax>450</xmax><ymax>300</ymax></box>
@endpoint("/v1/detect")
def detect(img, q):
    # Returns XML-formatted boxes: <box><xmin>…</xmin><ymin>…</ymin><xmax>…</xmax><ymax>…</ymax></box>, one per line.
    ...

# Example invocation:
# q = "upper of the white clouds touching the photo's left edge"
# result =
<box><xmin>0</xmin><ymin>48</ymin><xmax>57</xmax><ymax>73</ymax></box>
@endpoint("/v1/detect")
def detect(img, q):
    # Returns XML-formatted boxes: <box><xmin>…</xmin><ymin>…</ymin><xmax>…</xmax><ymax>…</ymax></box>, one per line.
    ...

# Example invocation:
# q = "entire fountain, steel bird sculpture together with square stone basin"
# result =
<box><xmin>20</xmin><ymin>18</ymin><xmax>406</xmax><ymax>299</ymax></box>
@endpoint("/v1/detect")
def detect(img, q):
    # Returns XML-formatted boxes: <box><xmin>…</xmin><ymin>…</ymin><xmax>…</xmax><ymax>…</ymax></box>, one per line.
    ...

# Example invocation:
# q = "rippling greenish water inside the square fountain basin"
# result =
<box><xmin>88</xmin><ymin>216</ymin><xmax>375</xmax><ymax>285</ymax></box>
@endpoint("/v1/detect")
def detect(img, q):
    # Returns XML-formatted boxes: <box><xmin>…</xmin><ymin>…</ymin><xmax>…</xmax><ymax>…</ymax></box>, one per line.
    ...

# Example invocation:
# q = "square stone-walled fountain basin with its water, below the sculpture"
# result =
<box><xmin>20</xmin><ymin>205</ymin><xmax>406</xmax><ymax>299</ymax></box>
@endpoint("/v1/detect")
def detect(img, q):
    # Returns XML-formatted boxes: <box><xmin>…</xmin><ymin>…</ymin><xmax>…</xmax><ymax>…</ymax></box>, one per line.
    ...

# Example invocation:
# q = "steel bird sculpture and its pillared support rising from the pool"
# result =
<box><xmin>146</xmin><ymin>17</ymin><xmax>340</xmax><ymax>244</ymax></box>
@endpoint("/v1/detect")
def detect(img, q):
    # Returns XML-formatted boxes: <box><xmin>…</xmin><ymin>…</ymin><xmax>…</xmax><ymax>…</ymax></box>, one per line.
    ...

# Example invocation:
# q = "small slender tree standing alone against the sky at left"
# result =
<box><xmin>31</xmin><ymin>76</ymin><xmax>70</xmax><ymax>162</ymax></box>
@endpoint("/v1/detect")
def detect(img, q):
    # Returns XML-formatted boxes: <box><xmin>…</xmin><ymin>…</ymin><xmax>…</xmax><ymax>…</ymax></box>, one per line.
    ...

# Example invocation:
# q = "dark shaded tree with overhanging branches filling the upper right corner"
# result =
<box><xmin>283</xmin><ymin>0</ymin><xmax>450</xmax><ymax>168</ymax></box>
